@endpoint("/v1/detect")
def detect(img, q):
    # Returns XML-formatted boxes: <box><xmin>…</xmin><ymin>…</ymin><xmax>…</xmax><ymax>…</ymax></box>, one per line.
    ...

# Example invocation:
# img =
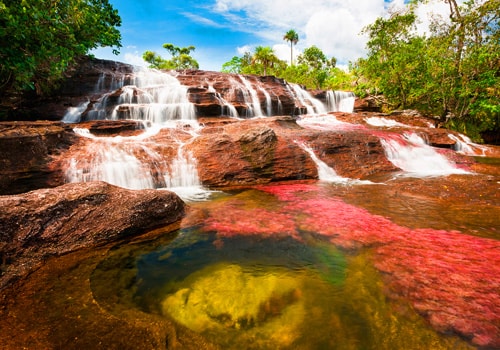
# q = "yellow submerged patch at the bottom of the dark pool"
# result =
<box><xmin>162</xmin><ymin>264</ymin><xmax>305</xmax><ymax>345</ymax></box>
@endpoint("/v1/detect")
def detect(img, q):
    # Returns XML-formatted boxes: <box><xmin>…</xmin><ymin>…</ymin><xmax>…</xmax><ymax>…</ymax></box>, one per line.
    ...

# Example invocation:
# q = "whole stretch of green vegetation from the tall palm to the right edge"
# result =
<box><xmin>222</xmin><ymin>0</ymin><xmax>500</xmax><ymax>141</ymax></box>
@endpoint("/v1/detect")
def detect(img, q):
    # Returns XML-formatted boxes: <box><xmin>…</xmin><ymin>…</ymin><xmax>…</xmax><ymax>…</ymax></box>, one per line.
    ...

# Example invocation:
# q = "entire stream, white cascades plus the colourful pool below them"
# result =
<box><xmin>49</xmin><ymin>67</ymin><xmax>500</xmax><ymax>350</ymax></box>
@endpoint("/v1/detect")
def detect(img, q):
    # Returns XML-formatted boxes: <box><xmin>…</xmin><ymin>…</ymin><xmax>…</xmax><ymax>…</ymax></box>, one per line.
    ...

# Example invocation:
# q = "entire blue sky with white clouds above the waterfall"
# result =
<box><xmin>93</xmin><ymin>0</ymin><xmax>452</xmax><ymax>71</ymax></box>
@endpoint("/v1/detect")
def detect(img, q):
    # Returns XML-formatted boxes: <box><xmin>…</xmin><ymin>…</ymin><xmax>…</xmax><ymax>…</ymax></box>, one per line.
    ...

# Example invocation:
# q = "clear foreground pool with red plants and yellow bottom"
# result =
<box><xmin>91</xmin><ymin>179</ymin><xmax>500</xmax><ymax>349</ymax></box>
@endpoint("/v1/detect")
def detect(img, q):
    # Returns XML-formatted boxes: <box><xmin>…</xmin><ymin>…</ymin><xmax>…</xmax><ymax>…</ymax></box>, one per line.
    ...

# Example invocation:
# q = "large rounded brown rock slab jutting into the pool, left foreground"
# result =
<box><xmin>0</xmin><ymin>182</ymin><xmax>184</xmax><ymax>288</ymax></box>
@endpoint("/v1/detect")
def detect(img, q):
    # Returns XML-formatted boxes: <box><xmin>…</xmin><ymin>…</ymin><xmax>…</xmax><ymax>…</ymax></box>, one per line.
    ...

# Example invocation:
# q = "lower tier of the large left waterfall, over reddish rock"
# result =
<box><xmin>66</xmin><ymin>128</ymin><xmax>209</xmax><ymax>200</ymax></box>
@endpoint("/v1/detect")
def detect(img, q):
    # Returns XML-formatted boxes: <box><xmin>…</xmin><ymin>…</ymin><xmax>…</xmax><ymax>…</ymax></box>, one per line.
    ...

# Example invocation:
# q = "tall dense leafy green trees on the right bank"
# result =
<box><xmin>354</xmin><ymin>0</ymin><xmax>500</xmax><ymax>141</ymax></box>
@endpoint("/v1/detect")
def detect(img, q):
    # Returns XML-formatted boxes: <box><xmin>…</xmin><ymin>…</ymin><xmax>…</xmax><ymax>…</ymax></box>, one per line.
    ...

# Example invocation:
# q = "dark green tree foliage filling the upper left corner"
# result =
<box><xmin>0</xmin><ymin>0</ymin><xmax>121</xmax><ymax>94</ymax></box>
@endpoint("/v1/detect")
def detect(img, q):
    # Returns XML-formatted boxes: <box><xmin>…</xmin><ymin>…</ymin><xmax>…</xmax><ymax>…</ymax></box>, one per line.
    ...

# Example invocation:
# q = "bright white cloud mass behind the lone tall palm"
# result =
<box><xmin>212</xmin><ymin>0</ymin><xmax>460</xmax><ymax>65</ymax></box>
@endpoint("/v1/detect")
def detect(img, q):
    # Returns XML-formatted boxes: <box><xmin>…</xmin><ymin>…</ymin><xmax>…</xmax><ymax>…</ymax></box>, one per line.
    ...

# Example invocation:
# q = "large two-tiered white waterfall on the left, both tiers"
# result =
<box><xmin>66</xmin><ymin>69</ymin><xmax>208</xmax><ymax>199</ymax></box>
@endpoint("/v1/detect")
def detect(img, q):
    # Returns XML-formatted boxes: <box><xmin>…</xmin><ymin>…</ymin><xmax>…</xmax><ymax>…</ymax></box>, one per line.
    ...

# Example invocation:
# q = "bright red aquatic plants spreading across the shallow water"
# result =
<box><xmin>205</xmin><ymin>184</ymin><xmax>500</xmax><ymax>347</ymax></box>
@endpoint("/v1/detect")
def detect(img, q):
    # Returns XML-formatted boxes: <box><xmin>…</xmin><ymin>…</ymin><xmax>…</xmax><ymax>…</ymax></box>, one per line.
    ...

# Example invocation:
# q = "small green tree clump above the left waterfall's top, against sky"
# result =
<box><xmin>142</xmin><ymin>44</ymin><xmax>200</xmax><ymax>70</ymax></box>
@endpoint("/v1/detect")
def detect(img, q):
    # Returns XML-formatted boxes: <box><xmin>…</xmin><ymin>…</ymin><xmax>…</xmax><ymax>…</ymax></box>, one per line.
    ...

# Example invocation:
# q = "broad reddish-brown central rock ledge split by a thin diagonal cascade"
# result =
<box><xmin>189</xmin><ymin>117</ymin><xmax>397</xmax><ymax>187</ymax></box>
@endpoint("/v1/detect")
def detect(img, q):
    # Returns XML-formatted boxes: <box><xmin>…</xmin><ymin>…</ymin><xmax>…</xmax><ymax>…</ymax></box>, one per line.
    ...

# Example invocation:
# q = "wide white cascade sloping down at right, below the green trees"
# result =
<box><xmin>381</xmin><ymin>133</ymin><xmax>468</xmax><ymax>177</ymax></box>
